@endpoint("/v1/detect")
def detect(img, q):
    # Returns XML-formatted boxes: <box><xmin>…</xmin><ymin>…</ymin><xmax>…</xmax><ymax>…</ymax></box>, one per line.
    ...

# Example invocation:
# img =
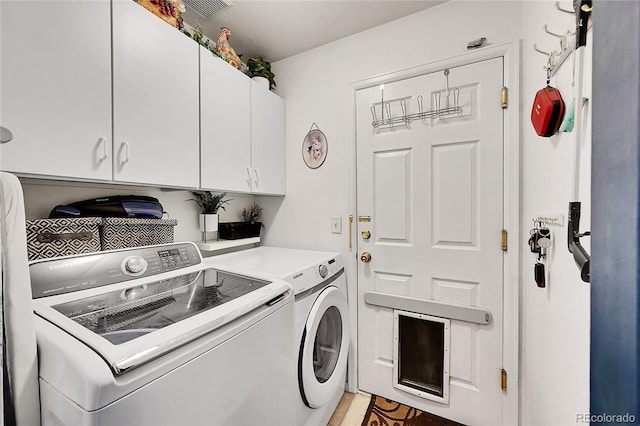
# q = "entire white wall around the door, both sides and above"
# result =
<box><xmin>268</xmin><ymin>0</ymin><xmax>590</xmax><ymax>425</ymax></box>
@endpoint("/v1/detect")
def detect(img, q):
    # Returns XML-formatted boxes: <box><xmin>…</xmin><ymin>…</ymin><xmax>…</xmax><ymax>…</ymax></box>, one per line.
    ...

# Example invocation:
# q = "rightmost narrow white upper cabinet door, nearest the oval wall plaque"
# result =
<box><xmin>251</xmin><ymin>81</ymin><xmax>285</xmax><ymax>195</ymax></box>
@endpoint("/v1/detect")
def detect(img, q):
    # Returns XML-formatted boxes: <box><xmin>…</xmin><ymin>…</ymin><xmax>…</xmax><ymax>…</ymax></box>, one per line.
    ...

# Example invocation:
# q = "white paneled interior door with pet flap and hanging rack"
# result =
<box><xmin>356</xmin><ymin>58</ymin><xmax>504</xmax><ymax>424</ymax></box>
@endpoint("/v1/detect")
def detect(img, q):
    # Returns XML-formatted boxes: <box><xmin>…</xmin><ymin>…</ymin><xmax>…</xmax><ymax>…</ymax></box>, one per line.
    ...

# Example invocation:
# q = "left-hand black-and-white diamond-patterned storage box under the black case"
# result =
<box><xmin>26</xmin><ymin>217</ymin><xmax>102</xmax><ymax>260</ymax></box>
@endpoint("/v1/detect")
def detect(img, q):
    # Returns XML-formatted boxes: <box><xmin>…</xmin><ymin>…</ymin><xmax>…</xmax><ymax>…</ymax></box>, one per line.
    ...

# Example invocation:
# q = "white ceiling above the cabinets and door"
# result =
<box><xmin>183</xmin><ymin>0</ymin><xmax>446</xmax><ymax>62</ymax></box>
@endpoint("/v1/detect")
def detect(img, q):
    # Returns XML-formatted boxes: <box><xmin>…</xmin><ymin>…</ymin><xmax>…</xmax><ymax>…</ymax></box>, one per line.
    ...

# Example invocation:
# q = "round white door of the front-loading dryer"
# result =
<box><xmin>298</xmin><ymin>286</ymin><xmax>349</xmax><ymax>408</ymax></box>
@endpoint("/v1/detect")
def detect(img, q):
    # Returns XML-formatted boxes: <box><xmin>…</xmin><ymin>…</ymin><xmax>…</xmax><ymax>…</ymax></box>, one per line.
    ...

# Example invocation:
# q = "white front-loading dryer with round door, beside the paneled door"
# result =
<box><xmin>211</xmin><ymin>246</ymin><xmax>350</xmax><ymax>426</ymax></box>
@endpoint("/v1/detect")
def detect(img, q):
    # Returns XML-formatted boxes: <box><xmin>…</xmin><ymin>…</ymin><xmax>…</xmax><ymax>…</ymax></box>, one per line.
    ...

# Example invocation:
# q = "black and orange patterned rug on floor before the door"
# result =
<box><xmin>362</xmin><ymin>395</ymin><xmax>462</xmax><ymax>426</ymax></box>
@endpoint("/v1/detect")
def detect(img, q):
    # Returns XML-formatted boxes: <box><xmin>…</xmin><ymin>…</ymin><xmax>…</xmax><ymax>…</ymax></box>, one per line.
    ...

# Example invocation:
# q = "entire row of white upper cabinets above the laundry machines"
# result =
<box><xmin>0</xmin><ymin>0</ymin><xmax>285</xmax><ymax>195</ymax></box>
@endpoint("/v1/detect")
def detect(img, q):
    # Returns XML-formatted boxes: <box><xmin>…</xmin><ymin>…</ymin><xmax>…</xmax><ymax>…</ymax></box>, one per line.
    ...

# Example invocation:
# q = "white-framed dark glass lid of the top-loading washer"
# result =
<box><xmin>34</xmin><ymin>269</ymin><xmax>291</xmax><ymax>374</ymax></box>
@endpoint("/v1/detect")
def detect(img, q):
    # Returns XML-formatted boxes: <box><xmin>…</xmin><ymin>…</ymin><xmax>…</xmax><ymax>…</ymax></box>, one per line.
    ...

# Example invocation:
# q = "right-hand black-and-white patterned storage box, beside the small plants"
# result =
<box><xmin>100</xmin><ymin>217</ymin><xmax>178</xmax><ymax>250</ymax></box>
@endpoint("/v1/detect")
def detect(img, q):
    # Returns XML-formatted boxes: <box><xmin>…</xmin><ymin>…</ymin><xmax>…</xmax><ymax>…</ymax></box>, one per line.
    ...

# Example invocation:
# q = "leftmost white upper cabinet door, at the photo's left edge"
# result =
<box><xmin>0</xmin><ymin>0</ymin><xmax>112</xmax><ymax>179</ymax></box>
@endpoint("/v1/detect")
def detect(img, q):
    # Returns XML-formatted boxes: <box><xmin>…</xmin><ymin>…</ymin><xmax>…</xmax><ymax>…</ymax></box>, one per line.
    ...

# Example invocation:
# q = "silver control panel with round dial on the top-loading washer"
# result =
<box><xmin>29</xmin><ymin>243</ymin><xmax>202</xmax><ymax>299</ymax></box>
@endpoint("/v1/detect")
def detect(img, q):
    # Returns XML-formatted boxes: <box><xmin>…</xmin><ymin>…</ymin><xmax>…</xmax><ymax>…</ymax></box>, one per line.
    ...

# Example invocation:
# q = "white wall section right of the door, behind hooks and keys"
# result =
<box><xmin>520</xmin><ymin>1</ymin><xmax>591</xmax><ymax>425</ymax></box>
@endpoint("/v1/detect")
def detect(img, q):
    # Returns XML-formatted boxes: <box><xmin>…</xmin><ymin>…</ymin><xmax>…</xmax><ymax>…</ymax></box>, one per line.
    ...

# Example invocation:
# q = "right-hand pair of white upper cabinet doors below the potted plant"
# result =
<box><xmin>200</xmin><ymin>48</ymin><xmax>285</xmax><ymax>195</ymax></box>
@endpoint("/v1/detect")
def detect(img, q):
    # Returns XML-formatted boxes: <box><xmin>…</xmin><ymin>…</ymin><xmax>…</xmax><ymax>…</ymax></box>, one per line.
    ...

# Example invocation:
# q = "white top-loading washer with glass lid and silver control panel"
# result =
<box><xmin>30</xmin><ymin>243</ymin><xmax>296</xmax><ymax>426</ymax></box>
